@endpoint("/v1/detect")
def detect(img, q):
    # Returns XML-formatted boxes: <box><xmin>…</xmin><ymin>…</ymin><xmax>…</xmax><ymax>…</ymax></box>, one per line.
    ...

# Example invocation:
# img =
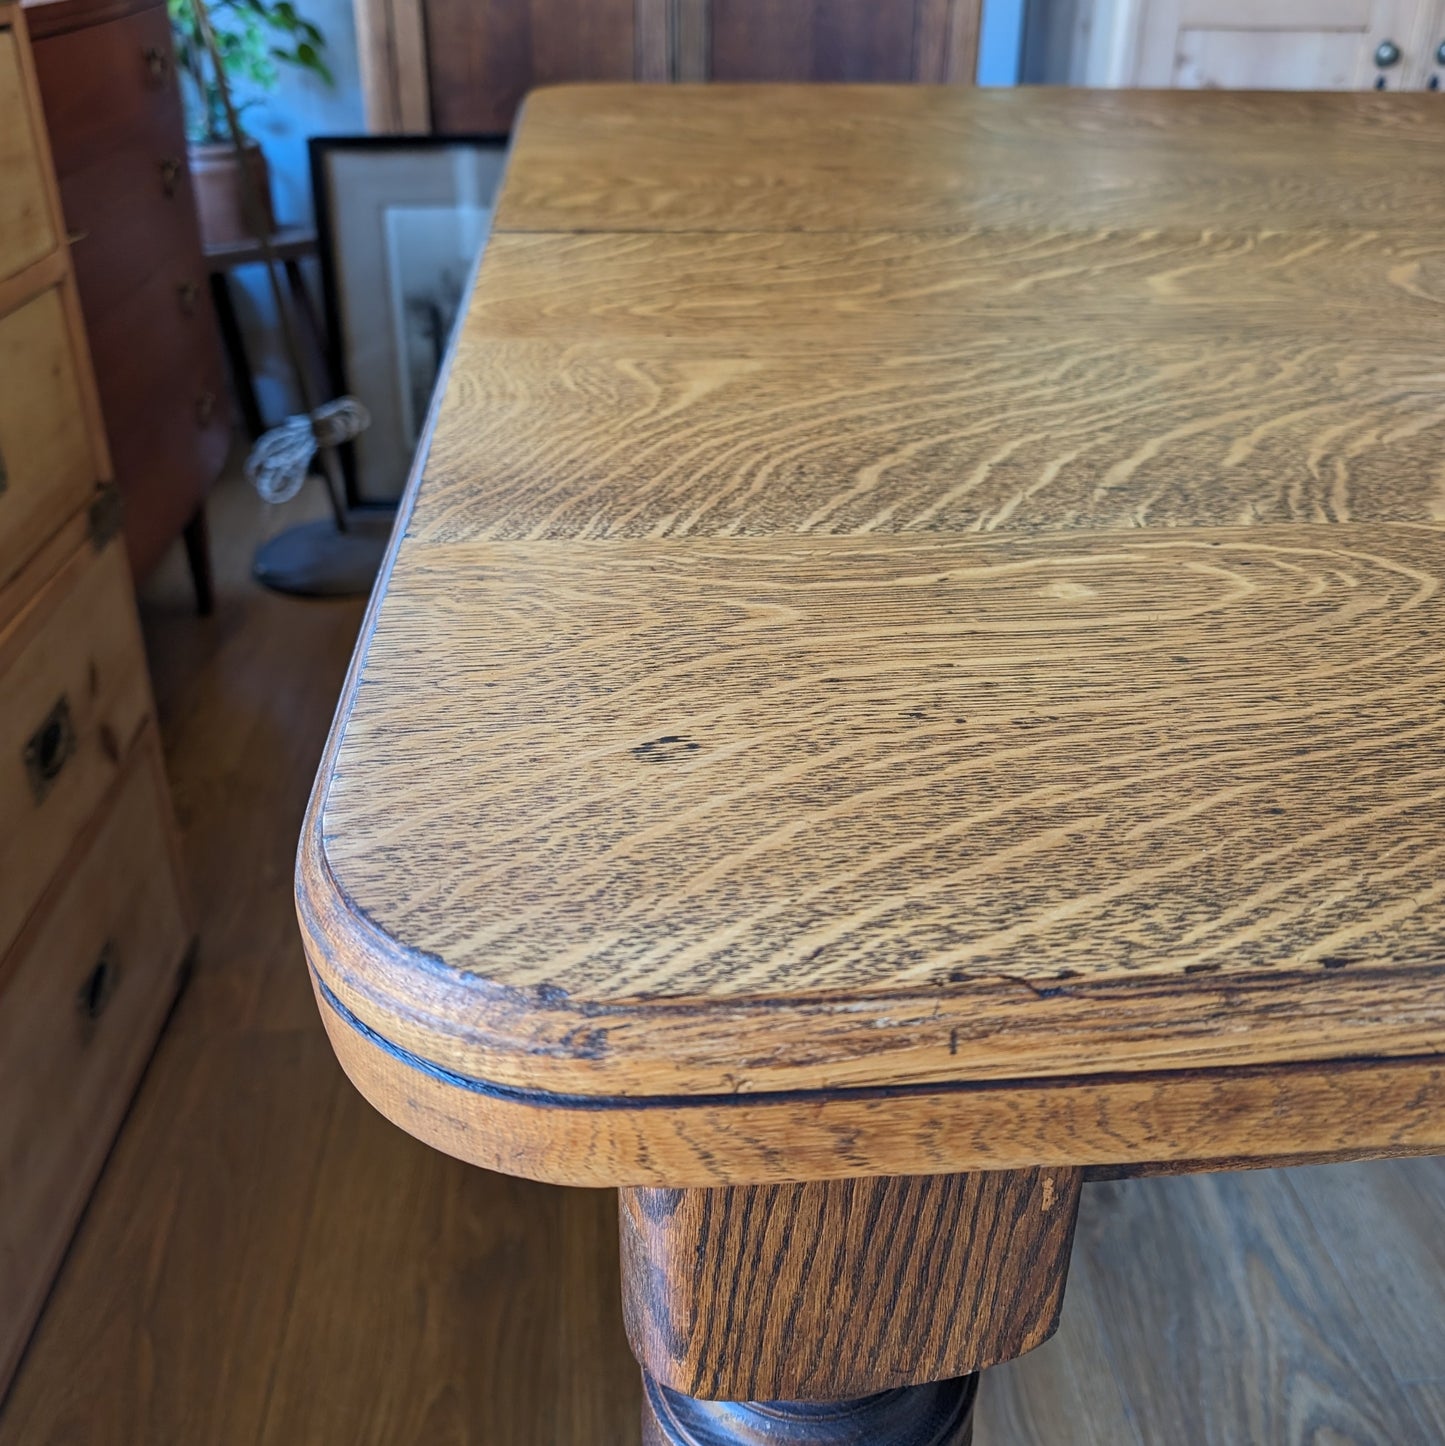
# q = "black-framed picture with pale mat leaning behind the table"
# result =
<box><xmin>310</xmin><ymin>136</ymin><xmax>508</xmax><ymax>506</ymax></box>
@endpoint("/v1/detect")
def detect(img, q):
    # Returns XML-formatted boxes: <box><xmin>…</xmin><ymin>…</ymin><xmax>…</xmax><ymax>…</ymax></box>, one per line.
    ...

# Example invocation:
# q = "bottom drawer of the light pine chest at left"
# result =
<box><xmin>0</xmin><ymin>729</ymin><xmax>188</xmax><ymax>1392</ymax></box>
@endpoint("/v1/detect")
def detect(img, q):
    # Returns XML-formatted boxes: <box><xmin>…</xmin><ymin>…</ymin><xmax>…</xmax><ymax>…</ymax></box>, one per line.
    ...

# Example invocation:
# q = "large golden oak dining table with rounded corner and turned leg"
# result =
<box><xmin>297</xmin><ymin>85</ymin><xmax>1445</xmax><ymax>1446</ymax></box>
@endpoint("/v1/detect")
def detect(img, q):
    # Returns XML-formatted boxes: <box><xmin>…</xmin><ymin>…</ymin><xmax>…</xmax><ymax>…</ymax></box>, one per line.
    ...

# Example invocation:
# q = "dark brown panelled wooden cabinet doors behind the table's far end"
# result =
<box><xmin>419</xmin><ymin>0</ymin><xmax>981</xmax><ymax>134</ymax></box>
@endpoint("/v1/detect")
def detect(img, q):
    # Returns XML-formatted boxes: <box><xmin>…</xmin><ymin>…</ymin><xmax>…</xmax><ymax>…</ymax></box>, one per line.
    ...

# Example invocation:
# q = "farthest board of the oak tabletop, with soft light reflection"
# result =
<box><xmin>496</xmin><ymin>85</ymin><xmax>1441</xmax><ymax>240</ymax></box>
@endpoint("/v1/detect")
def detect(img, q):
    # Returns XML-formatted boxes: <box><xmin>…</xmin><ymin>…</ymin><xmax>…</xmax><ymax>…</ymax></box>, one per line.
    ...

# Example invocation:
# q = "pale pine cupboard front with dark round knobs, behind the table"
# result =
<box><xmin>1134</xmin><ymin>0</ymin><xmax>1436</xmax><ymax>90</ymax></box>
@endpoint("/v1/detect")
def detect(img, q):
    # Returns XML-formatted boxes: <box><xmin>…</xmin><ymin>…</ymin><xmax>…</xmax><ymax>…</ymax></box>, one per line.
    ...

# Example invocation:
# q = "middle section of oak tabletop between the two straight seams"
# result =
<box><xmin>412</xmin><ymin>228</ymin><xmax>1445</xmax><ymax>541</ymax></box>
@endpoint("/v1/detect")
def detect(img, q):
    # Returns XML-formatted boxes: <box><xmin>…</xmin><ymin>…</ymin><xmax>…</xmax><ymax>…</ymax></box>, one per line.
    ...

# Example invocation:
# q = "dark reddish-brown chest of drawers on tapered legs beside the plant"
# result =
<box><xmin>26</xmin><ymin>0</ymin><xmax>230</xmax><ymax>606</ymax></box>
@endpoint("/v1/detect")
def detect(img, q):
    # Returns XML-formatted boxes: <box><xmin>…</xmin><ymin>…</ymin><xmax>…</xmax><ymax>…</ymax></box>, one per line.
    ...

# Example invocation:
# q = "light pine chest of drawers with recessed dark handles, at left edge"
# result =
<box><xmin>0</xmin><ymin>0</ymin><xmax>191</xmax><ymax>1391</ymax></box>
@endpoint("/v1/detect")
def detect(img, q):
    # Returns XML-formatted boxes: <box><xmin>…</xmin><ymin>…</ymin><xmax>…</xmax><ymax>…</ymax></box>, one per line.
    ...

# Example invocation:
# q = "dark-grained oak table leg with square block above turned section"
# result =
<box><xmin>621</xmin><ymin>1168</ymin><xmax>1080</xmax><ymax>1446</ymax></box>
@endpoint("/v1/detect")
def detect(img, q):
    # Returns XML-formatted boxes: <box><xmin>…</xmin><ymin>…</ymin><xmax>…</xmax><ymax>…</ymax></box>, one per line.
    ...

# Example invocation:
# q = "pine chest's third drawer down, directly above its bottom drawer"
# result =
<box><xmin>0</xmin><ymin>544</ymin><xmax>150</xmax><ymax>956</ymax></box>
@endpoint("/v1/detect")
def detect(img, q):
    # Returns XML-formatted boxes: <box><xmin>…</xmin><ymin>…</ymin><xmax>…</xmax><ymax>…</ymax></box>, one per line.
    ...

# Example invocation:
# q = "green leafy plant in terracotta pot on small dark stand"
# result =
<box><xmin>169</xmin><ymin>0</ymin><xmax>333</xmax><ymax>244</ymax></box>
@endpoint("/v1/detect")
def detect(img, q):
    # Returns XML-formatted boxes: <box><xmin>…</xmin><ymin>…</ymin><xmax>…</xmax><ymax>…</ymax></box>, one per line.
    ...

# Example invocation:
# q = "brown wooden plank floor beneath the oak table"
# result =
<box><xmin>0</xmin><ymin>468</ymin><xmax>1445</xmax><ymax>1446</ymax></box>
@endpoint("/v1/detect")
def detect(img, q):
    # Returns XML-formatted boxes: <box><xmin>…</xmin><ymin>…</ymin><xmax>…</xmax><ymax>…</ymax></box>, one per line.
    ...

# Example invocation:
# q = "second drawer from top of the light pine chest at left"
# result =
<box><xmin>0</xmin><ymin>289</ymin><xmax>100</xmax><ymax>587</ymax></box>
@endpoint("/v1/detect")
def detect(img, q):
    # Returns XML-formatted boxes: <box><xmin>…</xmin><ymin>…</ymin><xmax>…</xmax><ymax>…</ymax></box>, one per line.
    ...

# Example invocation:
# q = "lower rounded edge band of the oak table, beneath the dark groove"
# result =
<box><xmin>318</xmin><ymin>995</ymin><xmax>1445</xmax><ymax>1187</ymax></box>
